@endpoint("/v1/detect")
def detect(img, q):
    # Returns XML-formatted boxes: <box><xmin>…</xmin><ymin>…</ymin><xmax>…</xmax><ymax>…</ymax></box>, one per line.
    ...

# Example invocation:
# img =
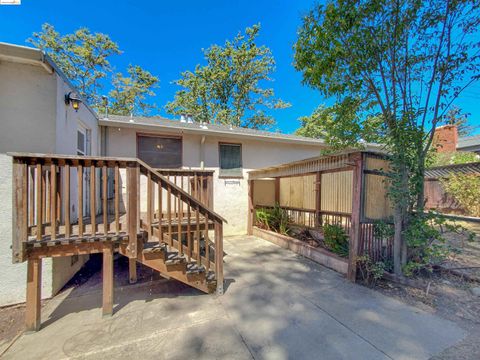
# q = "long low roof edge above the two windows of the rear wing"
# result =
<box><xmin>99</xmin><ymin>115</ymin><xmax>326</xmax><ymax>146</ymax></box>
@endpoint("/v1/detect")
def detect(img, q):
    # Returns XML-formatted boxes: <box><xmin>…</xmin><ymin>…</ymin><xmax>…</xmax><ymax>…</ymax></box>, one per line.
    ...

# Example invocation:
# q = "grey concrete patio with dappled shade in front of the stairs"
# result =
<box><xmin>5</xmin><ymin>237</ymin><xmax>465</xmax><ymax>360</ymax></box>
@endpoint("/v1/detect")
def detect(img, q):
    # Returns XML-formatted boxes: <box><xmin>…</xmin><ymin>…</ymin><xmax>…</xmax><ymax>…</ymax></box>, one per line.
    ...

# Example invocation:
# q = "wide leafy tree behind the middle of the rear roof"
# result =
<box><xmin>166</xmin><ymin>25</ymin><xmax>290</xmax><ymax>128</ymax></box>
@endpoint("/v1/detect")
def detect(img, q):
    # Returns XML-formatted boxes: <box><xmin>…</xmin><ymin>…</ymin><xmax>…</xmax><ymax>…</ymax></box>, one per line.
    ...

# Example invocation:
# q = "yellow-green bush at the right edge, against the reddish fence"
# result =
<box><xmin>440</xmin><ymin>174</ymin><xmax>480</xmax><ymax>217</ymax></box>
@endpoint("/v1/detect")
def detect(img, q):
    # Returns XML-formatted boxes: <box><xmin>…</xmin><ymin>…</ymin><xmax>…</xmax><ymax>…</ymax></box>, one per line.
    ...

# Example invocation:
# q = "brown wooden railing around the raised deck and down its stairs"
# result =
<box><xmin>10</xmin><ymin>153</ymin><xmax>224</xmax><ymax>294</ymax></box>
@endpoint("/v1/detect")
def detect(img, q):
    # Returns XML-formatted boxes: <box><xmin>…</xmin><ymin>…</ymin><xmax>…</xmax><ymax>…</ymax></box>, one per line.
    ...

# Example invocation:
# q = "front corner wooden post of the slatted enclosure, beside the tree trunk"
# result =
<box><xmin>347</xmin><ymin>153</ymin><xmax>363</xmax><ymax>282</ymax></box>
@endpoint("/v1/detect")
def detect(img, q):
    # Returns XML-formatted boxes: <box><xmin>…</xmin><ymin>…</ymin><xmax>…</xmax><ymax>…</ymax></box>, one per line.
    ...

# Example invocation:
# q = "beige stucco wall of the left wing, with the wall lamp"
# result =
<box><xmin>0</xmin><ymin>61</ymin><xmax>98</xmax><ymax>306</ymax></box>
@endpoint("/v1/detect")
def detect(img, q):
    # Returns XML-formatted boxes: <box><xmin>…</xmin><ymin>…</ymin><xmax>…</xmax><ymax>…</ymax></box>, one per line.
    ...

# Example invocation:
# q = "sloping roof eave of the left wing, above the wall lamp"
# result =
<box><xmin>0</xmin><ymin>42</ymin><xmax>98</xmax><ymax>118</ymax></box>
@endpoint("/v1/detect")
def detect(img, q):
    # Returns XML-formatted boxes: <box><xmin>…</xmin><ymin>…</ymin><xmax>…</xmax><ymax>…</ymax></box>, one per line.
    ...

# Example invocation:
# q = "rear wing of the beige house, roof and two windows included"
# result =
<box><xmin>99</xmin><ymin>115</ymin><xmax>325</xmax><ymax>235</ymax></box>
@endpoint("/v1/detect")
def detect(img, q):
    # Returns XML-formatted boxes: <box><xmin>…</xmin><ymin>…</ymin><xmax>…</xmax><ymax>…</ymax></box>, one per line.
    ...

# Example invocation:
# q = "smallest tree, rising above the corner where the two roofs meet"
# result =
<box><xmin>109</xmin><ymin>65</ymin><xmax>159</xmax><ymax>115</ymax></box>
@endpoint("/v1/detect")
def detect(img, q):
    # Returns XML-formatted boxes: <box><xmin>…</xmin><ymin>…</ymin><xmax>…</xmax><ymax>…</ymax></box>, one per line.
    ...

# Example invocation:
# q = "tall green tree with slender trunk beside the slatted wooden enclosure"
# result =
<box><xmin>295</xmin><ymin>0</ymin><xmax>480</xmax><ymax>274</ymax></box>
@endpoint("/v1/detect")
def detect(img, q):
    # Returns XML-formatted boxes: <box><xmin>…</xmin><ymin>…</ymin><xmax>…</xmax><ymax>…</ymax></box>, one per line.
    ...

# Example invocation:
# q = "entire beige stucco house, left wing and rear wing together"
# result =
<box><xmin>0</xmin><ymin>43</ymin><xmax>324</xmax><ymax>306</ymax></box>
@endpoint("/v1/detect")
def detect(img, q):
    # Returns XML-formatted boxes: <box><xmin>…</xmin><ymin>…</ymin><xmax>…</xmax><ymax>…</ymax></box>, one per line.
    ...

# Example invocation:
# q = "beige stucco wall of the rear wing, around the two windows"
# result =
<box><xmin>106</xmin><ymin>127</ymin><xmax>320</xmax><ymax>235</ymax></box>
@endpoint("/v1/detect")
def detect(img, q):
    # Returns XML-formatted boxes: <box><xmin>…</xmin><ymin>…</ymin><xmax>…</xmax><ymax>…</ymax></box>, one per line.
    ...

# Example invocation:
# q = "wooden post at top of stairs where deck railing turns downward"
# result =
<box><xmin>127</xmin><ymin>164</ymin><xmax>138</xmax><ymax>258</ymax></box>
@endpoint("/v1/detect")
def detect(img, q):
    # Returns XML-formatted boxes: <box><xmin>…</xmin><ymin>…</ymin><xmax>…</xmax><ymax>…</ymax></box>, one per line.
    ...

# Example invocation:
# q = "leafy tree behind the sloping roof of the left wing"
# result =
<box><xmin>27</xmin><ymin>23</ymin><xmax>120</xmax><ymax>107</ymax></box>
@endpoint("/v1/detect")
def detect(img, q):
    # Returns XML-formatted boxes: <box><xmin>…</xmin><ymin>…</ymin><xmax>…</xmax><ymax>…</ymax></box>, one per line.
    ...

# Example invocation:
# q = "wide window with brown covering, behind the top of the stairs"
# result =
<box><xmin>137</xmin><ymin>135</ymin><xmax>182</xmax><ymax>169</ymax></box>
